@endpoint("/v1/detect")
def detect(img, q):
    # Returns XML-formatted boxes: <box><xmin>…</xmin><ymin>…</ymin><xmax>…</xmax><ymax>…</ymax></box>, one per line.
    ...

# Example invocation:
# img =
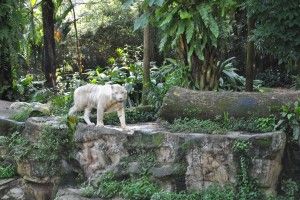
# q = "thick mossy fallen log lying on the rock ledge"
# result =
<box><xmin>159</xmin><ymin>87</ymin><xmax>300</xmax><ymax>121</ymax></box>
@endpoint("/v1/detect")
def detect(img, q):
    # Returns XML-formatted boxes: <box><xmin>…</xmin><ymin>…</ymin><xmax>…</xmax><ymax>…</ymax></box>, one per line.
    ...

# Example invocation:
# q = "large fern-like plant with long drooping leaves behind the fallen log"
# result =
<box><xmin>155</xmin><ymin>0</ymin><xmax>236</xmax><ymax>90</ymax></box>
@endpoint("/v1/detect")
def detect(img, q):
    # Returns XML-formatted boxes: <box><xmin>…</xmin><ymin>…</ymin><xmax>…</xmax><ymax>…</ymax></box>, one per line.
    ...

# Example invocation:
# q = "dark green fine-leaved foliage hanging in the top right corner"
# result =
<box><xmin>246</xmin><ymin>0</ymin><xmax>300</xmax><ymax>67</ymax></box>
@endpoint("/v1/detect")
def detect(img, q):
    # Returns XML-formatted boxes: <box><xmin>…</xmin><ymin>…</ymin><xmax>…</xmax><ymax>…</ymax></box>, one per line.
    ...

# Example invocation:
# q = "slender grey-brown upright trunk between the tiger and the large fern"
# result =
<box><xmin>142</xmin><ymin>24</ymin><xmax>151</xmax><ymax>105</ymax></box>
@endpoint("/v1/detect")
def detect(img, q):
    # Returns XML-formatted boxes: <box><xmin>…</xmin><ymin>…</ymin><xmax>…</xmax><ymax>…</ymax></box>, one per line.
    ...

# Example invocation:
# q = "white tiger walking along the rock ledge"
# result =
<box><xmin>69</xmin><ymin>84</ymin><xmax>127</xmax><ymax>129</ymax></box>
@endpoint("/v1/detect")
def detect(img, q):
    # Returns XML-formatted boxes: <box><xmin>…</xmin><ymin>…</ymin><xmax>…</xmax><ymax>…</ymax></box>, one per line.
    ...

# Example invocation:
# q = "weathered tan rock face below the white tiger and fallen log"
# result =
<box><xmin>75</xmin><ymin>123</ymin><xmax>286</xmax><ymax>193</ymax></box>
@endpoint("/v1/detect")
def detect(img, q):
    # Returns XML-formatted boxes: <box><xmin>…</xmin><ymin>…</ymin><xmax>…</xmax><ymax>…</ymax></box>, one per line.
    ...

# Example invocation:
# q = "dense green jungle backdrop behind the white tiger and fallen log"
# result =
<box><xmin>0</xmin><ymin>0</ymin><xmax>300</xmax><ymax>199</ymax></box>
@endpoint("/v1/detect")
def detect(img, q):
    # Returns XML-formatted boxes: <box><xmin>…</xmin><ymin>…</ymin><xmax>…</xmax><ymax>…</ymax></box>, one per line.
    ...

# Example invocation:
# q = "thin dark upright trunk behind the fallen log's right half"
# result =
<box><xmin>246</xmin><ymin>17</ymin><xmax>255</xmax><ymax>92</ymax></box>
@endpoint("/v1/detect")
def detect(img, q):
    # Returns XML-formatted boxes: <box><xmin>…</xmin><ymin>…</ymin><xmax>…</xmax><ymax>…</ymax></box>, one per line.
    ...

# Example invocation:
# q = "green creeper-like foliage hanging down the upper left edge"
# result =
<box><xmin>0</xmin><ymin>0</ymin><xmax>24</xmax><ymax>99</ymax></box>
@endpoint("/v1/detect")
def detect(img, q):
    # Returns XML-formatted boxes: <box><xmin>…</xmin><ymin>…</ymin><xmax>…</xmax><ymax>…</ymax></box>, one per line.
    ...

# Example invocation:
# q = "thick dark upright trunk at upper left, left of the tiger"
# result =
<box><xmin>42</xmin><ymin>0</ymin><xmax>56</xmax><ymax>87</ymax></box>
